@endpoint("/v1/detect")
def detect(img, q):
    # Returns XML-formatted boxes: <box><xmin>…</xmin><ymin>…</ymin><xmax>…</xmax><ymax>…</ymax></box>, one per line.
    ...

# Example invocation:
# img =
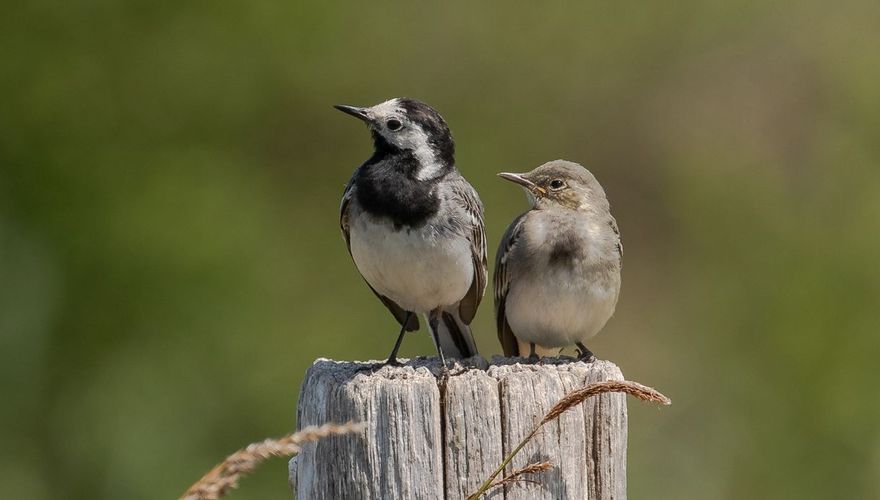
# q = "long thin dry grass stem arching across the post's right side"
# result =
<box><xmin>468</xmin><ymin>380</ymin><xmax>672</xmax><ymax>500</ymax></box>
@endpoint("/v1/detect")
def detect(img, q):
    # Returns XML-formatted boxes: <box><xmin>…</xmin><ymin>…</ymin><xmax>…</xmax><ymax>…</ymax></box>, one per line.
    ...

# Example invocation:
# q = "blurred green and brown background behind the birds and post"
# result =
<box><xmin>0</xmin><ymin>0</ymin><xmax>880</xmax><ymax>499</ymax></box>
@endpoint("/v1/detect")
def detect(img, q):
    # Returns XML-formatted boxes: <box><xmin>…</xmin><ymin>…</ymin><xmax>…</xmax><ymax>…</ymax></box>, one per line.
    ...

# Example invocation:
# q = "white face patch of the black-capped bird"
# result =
<box><xmin>368</xmin><ymin>98</ymin><xmax>443</xmax><ymax>180</ymax></box>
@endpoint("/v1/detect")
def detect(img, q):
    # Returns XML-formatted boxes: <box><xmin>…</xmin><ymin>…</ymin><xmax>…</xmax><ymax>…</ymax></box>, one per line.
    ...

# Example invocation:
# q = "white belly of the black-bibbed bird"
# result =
<box><xmin>350</xmin><ymin>213</ymin><xmax>474</xmax><ymax>313</ymax></box>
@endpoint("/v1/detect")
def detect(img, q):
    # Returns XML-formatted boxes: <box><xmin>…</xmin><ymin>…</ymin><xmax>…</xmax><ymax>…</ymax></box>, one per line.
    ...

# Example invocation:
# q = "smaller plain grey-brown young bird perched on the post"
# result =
<box><xmin>493</xmin><ymin>160</ymin><xmax>623</xmax><ymax>361</ymax></box>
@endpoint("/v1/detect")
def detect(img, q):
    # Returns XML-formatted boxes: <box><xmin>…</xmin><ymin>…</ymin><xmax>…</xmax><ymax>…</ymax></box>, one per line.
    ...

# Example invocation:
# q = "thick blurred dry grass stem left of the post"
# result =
<box><xmin>180</xmin><ymin>422</ymin><xmax>363</xmax><ymax>500</ymax></box>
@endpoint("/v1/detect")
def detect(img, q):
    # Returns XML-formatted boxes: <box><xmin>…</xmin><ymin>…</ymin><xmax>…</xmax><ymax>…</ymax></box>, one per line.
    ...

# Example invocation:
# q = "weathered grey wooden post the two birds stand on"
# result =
<box><xmin>290</xmin><ymin>357</ymin><xmax>627</xmax><ymax>500</ymax></box>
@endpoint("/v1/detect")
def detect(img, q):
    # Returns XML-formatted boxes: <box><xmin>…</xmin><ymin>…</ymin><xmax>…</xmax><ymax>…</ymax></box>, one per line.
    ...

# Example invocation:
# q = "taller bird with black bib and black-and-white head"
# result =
<box><xmin>334</xmin><ymin>97</ymin><xmax>487</xmax><ymax>372</ymax></box>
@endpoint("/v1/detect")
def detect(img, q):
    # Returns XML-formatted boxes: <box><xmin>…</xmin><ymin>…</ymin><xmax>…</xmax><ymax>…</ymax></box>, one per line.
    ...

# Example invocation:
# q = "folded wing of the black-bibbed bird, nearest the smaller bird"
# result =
<box><xmin>452</xmin><ymin>176</ymin><xmax>487</xmax><ymax>325</ymax></box>
